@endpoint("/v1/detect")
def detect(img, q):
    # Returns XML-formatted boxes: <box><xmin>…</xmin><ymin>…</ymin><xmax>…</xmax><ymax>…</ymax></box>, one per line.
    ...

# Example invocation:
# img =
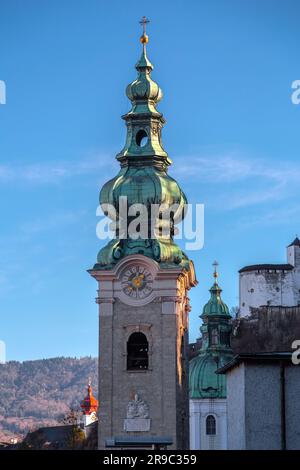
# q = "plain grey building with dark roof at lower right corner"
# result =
<box><xmin>218</xmin><ymin>352</ymin><xmax>300</xmax><ymax>450</ymax></box>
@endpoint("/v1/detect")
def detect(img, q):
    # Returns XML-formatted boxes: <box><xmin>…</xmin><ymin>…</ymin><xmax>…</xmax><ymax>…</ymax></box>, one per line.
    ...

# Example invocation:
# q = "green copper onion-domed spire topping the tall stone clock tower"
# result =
<box><xmin>93</xmin><ymin>29</ymin><xmax>190</xmax><ymax>270</ymax></box>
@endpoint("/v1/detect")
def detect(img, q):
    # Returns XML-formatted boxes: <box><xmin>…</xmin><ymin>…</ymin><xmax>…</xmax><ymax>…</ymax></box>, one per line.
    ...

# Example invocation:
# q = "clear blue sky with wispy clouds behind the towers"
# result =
<box><xmin>0</xmin><ymin>0</ymin><xmax>300</xmax><ymax>360</ymax></box>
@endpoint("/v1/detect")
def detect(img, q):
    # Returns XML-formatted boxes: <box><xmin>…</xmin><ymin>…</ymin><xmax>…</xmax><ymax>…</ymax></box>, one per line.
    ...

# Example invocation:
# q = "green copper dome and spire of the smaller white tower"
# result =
<box><xmin>189</xmin><ymin>263</ymin><xmax>233</xmax><ymax>398</ymax></box>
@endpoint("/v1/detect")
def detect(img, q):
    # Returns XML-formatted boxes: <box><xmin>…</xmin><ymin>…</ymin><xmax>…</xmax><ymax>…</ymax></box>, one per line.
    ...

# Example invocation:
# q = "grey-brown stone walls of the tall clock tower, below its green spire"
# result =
<box><xmin>90</xmin><ymin>255</ymin><xmax>195</xmax><ymax>449</ymax></box>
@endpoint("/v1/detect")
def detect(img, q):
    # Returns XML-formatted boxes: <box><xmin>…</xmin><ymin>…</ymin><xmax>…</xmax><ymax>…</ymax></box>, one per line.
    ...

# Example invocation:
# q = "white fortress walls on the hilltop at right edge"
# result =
<box><xmin>239</xmin><ymin>237</ymin><xmax>300</xmax><ymax>317</ymax></box>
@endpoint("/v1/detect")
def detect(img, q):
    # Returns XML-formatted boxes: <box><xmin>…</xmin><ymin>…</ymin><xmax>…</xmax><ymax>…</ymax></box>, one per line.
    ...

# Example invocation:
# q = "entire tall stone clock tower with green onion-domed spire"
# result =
<box><xmin>89</xmin><ymin>18</ymin><xmax>196</xmax><ymax>449</ymax></box>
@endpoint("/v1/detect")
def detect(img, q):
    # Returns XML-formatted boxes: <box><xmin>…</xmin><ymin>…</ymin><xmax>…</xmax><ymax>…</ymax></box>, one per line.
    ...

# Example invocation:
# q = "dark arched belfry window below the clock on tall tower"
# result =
<box><xmin>127</xmin><ymin>333</ymin><xmax>149</xmax><ymax>370</ymax></box>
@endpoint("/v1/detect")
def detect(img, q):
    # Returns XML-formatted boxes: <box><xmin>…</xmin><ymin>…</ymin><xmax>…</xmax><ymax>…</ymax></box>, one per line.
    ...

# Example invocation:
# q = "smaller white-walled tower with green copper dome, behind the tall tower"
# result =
<box><xmin>189</xmin><ymin>263</ymin><xmax>233</xmax><ymax>450</ymax></box>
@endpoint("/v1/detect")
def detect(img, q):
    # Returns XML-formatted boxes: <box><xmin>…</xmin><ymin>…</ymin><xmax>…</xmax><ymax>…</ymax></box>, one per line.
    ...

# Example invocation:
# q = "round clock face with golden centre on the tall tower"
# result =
<box><xmin>122</xmin><ymin>266</ymin><xmax>153</xmax><ymax>299</ymax></box>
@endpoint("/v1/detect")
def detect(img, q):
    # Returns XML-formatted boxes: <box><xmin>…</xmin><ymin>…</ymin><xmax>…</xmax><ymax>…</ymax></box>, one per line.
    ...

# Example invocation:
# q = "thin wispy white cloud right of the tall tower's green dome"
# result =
<box><xmin>173</xmin><ymin>154</ymin><xmax>300</xmax><ymax>210</ymax></box>
